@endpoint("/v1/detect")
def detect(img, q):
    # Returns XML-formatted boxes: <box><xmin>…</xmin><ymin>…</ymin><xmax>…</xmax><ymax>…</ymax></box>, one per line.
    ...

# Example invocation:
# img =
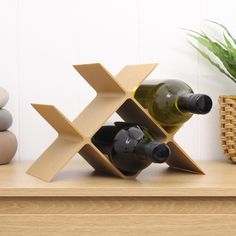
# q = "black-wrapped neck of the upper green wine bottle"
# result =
<box><xmin>177</xmin><ymin>94</ymin><xmax>212</xmax><ymax>114</ymax></box>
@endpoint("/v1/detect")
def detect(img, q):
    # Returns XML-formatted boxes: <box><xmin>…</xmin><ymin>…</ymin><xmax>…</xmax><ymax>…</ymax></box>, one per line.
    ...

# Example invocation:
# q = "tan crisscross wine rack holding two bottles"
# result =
<box><xmin>27</xmin><ymin>63</ymin><xmax>204</xmax><ymax>182</ymax></box>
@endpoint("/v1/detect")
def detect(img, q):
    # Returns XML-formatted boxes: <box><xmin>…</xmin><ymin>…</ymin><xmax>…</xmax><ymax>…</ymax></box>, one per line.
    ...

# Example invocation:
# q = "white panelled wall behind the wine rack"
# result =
<box><xmin>0</xmin><ymin>0</ymin><xmax>236</xmax><ymax>159</ymax></box>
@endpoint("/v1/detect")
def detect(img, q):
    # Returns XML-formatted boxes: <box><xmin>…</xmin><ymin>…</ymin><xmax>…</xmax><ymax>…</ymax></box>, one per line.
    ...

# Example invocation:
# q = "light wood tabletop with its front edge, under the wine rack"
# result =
<box><xmin>0</xmin><ymin>159</ymin><xmax>236</xmax><ymax>197</ymax></box>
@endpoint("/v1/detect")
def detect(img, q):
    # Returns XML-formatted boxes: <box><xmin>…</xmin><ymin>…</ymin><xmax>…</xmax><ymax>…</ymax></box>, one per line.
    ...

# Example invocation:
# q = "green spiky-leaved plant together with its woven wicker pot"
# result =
<box><xmin>187</xmin><ymin>21</ymin><xmax>236</xmax><ymax>163</ymax></box>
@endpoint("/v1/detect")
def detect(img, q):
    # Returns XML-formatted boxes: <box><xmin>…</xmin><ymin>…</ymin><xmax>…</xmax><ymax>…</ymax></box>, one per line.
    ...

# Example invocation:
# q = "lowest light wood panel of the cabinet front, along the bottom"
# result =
<box><xmin>0</xmin><ymin>214</ymin><xmax>236</xmax><ymax>236</ymax></box>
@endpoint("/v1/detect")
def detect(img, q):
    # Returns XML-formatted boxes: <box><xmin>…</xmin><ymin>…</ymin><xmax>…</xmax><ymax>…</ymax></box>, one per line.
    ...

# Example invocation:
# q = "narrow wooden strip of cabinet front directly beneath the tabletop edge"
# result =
<box><xmin>0</xmin><ymin>197</ymin><xmax>236</xmax><ymax>215</ymax></box>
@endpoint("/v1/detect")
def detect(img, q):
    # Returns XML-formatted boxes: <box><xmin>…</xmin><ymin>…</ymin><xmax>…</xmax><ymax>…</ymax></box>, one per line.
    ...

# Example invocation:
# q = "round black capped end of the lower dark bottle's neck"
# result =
<box><xmin>152</xmin><ymin>143</ymin><xmax>171</xmax><ymax>163</ymax></box>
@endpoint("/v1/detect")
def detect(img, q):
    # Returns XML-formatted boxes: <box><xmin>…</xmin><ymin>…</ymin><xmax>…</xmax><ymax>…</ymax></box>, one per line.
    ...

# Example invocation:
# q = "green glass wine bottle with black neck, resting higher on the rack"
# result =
<box><xmin>134</xmin><ymin>80</ymin><xmax>212</xmax><ymax>128</ymax></box>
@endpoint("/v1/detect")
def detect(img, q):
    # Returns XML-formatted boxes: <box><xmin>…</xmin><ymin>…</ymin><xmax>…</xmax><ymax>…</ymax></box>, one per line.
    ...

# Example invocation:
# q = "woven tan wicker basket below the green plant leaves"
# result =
<box><xmin>219</xmin><ymin>96</ymin><xmax>236</xmax><ymax>163</ymax></box>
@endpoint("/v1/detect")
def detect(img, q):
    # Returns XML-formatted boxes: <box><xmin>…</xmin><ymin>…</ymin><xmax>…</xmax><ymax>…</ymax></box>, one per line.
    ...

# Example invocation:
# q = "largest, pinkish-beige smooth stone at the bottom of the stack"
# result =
<box><xmin>0</xmin><ymin>131</ymin><xmax>17</xmax><ymax>165</ymax></box>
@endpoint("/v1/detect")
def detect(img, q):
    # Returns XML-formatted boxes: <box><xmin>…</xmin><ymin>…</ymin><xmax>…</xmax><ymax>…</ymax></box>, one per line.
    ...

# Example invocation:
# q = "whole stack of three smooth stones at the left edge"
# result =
<box><xmin>0</xmin><ymin>87</ymin><xmax>17</xmax><ymax>165</ymax></box>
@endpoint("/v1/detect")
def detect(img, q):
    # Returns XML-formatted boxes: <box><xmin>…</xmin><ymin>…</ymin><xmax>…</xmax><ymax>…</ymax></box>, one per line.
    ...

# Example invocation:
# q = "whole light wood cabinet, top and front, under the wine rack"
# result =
<box><xmin>0</xmin><ymin>160</ymin><xmax>236</xmax><ymax>236</ymax></box>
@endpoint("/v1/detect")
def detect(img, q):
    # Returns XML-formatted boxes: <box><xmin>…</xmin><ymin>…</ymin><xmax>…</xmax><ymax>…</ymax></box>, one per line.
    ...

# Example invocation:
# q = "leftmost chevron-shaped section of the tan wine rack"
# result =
<box><xmin>27</xmin><ymin>104</ymin><xmax>84</xmax><ymax>181</ymax></box>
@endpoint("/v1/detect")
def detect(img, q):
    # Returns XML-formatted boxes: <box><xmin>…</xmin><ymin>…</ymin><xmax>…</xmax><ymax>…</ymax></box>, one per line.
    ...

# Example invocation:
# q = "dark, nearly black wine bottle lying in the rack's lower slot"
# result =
<box><xmin>92</xmin><ymin>122</ymin><xmax>170</xmax><ymax>175</ymax></box>
